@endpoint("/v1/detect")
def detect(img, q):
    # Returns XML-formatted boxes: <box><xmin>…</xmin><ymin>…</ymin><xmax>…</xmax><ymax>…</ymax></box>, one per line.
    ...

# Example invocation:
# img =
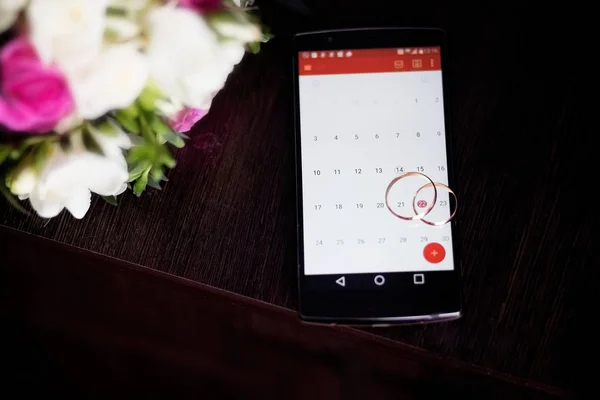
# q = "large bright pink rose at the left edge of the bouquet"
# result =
<box><xmin>0</xmin><ymin>38</ymin><xmax>74</xmax><ymax>133</ymax></box>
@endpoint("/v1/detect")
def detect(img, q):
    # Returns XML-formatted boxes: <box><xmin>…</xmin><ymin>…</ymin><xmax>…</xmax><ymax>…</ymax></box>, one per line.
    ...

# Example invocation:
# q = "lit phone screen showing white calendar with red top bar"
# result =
<box><xmin>298</xmin><ymin>46</ymin><xmax>454</xmax><ymax>276</ymax></box>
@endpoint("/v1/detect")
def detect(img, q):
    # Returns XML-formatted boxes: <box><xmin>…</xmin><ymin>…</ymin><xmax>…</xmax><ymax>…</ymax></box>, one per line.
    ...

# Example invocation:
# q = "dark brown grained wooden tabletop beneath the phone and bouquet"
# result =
<box><xmin>0</xmin><ymin>0</ymin><xmax>598</xmax><ymax>392</ymax></box>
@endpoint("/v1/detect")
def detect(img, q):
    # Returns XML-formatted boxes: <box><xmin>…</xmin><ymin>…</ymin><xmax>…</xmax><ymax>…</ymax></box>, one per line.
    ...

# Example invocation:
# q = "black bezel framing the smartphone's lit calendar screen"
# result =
<box><xmin>292</xmin><ymin>28</ymin><xmax>461</xmax><ymax>325</ymax></box>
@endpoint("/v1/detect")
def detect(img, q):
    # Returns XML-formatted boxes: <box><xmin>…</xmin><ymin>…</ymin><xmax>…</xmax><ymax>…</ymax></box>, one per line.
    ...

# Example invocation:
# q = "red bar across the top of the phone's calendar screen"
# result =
<box><xmin>298</xmin><ymin>47</ymin><xmax>441</xmax><ymax>75</ymax></box>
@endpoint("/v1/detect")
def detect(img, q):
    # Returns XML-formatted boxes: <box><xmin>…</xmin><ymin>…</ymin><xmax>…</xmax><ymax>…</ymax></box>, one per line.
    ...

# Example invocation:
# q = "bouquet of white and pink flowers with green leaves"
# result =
<box><xmin>0</xmin><ymin>0</ymin><xmax>268</xmax><ymax>218</ymax></box>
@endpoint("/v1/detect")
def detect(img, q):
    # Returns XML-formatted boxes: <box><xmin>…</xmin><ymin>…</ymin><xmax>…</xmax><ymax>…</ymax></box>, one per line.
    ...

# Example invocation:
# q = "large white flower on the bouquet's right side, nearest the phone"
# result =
<box><xmin>147</xmin><ymin>5</ymin><xmax>244</xmax><ymax>109</ymax></box>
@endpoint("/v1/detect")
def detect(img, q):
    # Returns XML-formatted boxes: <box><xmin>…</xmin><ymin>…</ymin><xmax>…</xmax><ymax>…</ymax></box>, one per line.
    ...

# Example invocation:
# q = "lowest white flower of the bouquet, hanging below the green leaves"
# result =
<box><xmin>11</xmin><ymin>126</ymin><xmax>131</xmax><ymax>219</ymax></box>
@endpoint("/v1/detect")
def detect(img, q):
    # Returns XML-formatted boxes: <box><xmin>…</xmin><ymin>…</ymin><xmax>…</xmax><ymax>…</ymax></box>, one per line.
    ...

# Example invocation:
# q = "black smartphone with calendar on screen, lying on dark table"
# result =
<box><xmin>293</xmin><ymin>28</ymin><xmax>461</xmax><ymax>325</ymax></box>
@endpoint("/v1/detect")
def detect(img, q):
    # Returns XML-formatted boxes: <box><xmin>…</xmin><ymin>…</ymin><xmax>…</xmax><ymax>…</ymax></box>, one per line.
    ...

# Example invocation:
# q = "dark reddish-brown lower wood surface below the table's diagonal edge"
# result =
<box><xmin>0</xmin><ymin>227</ymin><xmax>570</xmax><ymax>400</ymax></box>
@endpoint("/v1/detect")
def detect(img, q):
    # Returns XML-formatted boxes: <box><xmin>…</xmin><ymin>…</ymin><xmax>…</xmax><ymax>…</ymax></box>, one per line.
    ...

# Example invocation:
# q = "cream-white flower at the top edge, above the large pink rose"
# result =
<box><xmin>27</xmin><ymin>0</ymin><xmax>108</xmax><ymax>70</ymax></box>
